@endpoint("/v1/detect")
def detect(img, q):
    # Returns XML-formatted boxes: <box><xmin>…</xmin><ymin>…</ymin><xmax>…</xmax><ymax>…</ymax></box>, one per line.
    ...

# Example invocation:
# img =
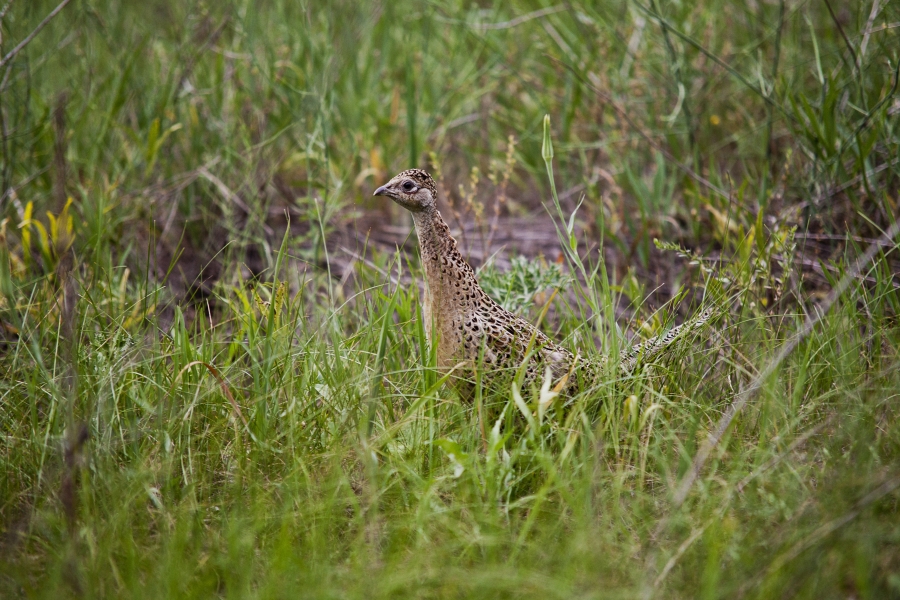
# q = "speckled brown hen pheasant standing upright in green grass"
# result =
<box><xmin>374</xmin><ymin>169</ymin><xmax>711</xmax><ymax>396</ymax></box>
